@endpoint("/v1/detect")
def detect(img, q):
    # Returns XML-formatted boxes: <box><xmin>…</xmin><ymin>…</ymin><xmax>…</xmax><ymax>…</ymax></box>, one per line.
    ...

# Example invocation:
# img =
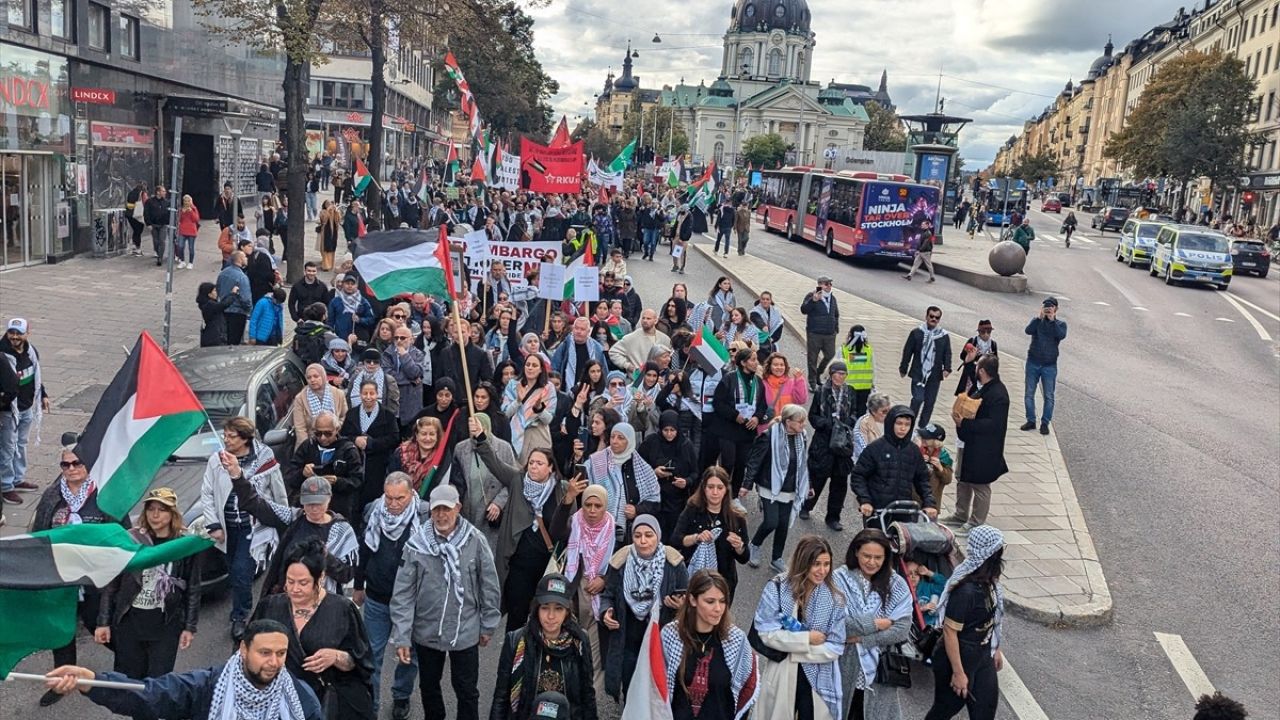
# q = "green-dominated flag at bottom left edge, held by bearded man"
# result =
<box><xmin>0</xmin><ymin>523</ymin><xmax>214</xmax><ymax>679</ymax></box>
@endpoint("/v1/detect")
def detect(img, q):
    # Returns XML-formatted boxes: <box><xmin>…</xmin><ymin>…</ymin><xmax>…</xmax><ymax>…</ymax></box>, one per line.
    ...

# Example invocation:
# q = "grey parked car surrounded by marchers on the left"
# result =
<box><xmin>151</xmin><ymin>345</ymin><xmax>306</xmax><ymax>593</ymax></box>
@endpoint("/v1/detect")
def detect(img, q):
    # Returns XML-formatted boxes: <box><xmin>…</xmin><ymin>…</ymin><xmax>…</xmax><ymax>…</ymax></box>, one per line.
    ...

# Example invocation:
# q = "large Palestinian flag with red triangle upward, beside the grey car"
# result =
<box><xmin>76</xmin><ymin>332</ymin><xmax>206</xmax><ymax>518</ymax></box>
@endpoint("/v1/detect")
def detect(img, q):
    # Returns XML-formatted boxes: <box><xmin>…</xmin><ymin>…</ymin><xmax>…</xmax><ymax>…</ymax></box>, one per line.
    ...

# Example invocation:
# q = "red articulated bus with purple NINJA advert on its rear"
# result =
<box><xmin>756</xmin><ymin>167</ymin><xmax>942</xmax><ymax>260</ymax></box>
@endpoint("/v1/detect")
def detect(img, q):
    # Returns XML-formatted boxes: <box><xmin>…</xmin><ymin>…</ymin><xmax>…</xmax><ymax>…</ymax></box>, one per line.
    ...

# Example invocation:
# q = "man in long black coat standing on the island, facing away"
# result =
<box><xmin>946</xmin><ymin>355</ymin><xmax>1009</xmax><ymax>532</ymax></box>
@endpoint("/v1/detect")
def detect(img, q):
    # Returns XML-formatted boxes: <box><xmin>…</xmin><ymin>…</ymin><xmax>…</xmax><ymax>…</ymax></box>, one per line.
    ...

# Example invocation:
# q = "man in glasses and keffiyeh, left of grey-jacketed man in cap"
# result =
<box><xmin>353</xmin><ymin>473</ymin><xmax>431</xmax><ymax>720</ymax></box>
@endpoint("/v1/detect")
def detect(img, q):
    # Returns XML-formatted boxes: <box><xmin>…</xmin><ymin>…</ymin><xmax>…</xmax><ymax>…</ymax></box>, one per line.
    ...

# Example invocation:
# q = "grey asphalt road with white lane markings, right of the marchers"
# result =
<box><xmin>731</xmin><ymin>203</ymin><xmax>1280</xmax><ymax>720</ymax></box>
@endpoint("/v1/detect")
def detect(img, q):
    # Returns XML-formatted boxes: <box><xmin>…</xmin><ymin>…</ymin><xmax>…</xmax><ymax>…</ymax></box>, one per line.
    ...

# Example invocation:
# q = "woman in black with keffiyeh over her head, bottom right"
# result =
<box><xmin>924</xmin><ymin>525</ymin><xmax>1005</xmax><ymax>720</ymax></box>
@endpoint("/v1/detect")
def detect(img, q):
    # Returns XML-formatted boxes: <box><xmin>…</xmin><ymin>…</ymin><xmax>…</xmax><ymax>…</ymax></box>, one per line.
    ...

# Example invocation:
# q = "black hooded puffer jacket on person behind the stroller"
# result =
<box><xmin>850</xmin><ymin>405</ymin><xmax>938</xmax><ymax>509</ymax></box>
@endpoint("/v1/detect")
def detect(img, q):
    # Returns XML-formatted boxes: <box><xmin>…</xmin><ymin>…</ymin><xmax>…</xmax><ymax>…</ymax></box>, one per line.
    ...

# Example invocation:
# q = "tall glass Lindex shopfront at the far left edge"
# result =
<box><xmin>0</xmin><ymin>45</ymin><xmax>76</xmax><ymax>269</ymax></box>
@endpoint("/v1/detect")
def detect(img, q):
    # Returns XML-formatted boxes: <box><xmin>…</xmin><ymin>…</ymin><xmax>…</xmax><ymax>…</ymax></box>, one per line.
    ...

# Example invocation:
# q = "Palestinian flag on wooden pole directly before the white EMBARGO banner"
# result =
<box><xmin>356</xmin><ymin>225</ymin><xmax>449</xmax><ymax>300</ymax></box>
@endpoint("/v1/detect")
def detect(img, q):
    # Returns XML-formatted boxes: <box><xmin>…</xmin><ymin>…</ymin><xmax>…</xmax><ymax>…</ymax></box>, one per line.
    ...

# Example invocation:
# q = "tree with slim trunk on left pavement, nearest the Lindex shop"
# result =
<box><xmin>192</xmin><ymin>0</ymin><xmax>329</xmax><ymax>283</ymax></box>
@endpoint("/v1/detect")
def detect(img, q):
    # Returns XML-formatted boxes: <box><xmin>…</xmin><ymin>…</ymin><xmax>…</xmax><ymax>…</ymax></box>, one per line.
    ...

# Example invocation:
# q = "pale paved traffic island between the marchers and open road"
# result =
<box><xmin>690</xmin><ymin>238</ymin><xmax>1111</xmax><ymax>625</ymax></box>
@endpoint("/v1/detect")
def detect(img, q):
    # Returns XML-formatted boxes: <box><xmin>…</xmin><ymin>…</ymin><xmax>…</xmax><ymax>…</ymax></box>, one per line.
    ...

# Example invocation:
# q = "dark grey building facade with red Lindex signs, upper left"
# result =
<box><xmin>0</xmin><ymin>0</ymin><xmax>283</xmax><ymax>268</ymax></box>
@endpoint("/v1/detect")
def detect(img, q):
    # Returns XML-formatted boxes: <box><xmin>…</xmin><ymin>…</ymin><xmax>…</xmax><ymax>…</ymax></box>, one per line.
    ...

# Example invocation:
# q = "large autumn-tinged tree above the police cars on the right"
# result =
<box><xmin>1103</xmin><ymin>51</ymin><xmax>1257</xmax><ymax>207</ymax></box>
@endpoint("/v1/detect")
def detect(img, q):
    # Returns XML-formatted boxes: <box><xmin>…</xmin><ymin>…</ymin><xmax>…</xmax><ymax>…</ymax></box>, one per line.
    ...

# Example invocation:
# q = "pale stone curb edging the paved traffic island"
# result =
<box><xmin>690</xmin><ymin>243</ymin><xmax>1114</xmax><ymax>628</ymax></box>
